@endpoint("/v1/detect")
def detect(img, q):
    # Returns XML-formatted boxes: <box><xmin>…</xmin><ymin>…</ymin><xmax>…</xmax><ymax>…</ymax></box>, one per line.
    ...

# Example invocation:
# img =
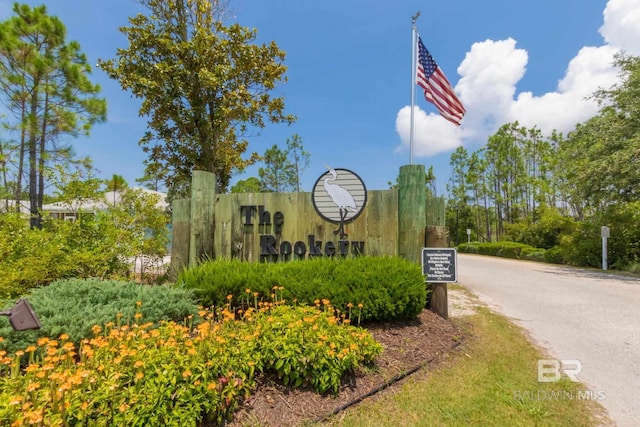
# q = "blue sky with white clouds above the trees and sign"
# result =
<box><xmin>0</xmin><ymin>0</ymin><xmax>640</xmax><ymax>194</ymax></box>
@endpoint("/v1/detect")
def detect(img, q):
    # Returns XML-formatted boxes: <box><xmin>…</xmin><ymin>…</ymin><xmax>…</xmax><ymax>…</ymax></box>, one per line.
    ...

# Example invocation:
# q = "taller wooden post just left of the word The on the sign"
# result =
<box><xmin>189</xmin><ymin>171</ymin><xmax>216</xmax><ymax>267</ymax></box>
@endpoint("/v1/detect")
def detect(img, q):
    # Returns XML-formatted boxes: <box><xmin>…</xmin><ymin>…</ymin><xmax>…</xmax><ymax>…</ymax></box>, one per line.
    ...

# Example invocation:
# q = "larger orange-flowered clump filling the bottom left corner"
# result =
<box><xmin>0</xmin><ymin>310</ymin><xmax>255</xmax><ymax>427</ymax></box>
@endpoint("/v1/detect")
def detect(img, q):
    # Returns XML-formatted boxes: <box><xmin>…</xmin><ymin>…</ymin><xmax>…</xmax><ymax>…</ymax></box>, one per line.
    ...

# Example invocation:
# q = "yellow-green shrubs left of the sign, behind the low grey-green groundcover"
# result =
<box><xmin>0</xmin><ymin>180</ymin><xmax>169</xmax><ymax>298</ymax></box>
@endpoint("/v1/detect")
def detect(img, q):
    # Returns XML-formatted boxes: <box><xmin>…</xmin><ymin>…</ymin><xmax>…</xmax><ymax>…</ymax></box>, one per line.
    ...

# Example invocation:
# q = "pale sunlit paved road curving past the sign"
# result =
<box><xmin>457</xmin><ymin>253</ymin><xmax>640</xmax><ymax>427</ymax></box>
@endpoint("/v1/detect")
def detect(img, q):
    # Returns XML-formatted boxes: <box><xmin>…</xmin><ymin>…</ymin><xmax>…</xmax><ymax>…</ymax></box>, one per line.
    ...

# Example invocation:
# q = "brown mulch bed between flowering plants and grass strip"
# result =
<box><xmin>227</xmin><ymin>310</ymin><xmax>464</xmax><ymax>427</ymax></box>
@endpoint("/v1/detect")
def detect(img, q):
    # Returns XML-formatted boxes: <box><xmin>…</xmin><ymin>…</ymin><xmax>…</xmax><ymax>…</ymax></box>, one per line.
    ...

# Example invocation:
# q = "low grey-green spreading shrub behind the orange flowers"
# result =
<box><xmin>0</xmin><ymin>279</ymin><xmax>198</xmax><ymax>360</ymax></box>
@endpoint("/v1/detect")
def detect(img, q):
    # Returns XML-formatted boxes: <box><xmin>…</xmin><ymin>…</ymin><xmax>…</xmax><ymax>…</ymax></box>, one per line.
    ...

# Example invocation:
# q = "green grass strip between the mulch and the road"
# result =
<box><xmin>323</xmin><ymin>307</ymin><xmax>613</xmax><ymax>427</ymax></box>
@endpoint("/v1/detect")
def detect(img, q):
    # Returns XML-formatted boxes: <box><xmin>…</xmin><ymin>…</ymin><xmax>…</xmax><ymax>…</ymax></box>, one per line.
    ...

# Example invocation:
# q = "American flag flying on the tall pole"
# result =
<box><xmin>416</xmin><ymin>37</ymin><xmax>466</xmax><ymax>126</ymax></box>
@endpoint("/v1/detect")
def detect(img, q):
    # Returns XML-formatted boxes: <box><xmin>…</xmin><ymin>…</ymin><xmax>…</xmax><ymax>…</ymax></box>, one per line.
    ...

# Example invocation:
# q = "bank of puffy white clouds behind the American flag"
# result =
<box><xmin>396</xmin><ymin>0</ymin><xmax>640</xmax><ymax>157</ymax></box>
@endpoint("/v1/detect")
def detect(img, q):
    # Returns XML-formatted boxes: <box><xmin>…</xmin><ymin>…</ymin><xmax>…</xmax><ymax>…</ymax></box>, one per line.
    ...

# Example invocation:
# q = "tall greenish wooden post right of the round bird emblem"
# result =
<box><xmin>398</xmin><ymin>165</ymin><xmax>427</xmax><ymax>263</ymax></box>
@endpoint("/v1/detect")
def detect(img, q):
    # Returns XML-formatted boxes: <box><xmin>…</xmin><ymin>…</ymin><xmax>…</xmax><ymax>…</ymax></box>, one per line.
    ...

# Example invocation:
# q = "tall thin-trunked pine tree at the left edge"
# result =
<box><xmin>0</xmin><ymin>3</ymin><xmax>106</xmax><ymax>227</ymax></box>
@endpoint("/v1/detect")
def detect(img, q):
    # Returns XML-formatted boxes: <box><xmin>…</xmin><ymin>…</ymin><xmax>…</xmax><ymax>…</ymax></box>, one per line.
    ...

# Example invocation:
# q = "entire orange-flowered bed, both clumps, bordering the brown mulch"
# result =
<box><xmin>0</xmin><ymin>303</ymin><xmax>382</xmax><ymax>427</ymax></box>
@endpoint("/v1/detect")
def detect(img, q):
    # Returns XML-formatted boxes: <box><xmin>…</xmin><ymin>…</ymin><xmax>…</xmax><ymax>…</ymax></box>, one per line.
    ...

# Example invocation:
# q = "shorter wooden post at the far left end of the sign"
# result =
<box><xmin>169</xmin><ymin>199</ymin><xmax>191</xmax><ymax>280</ymax></box>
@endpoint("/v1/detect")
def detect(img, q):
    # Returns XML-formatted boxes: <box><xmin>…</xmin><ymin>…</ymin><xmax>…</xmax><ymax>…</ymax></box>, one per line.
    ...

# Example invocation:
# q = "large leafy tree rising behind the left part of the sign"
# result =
<box><xmin>98</xmin><ymin>0</ymin><xmax>295</xmax><ymax>193</ymax></box>
